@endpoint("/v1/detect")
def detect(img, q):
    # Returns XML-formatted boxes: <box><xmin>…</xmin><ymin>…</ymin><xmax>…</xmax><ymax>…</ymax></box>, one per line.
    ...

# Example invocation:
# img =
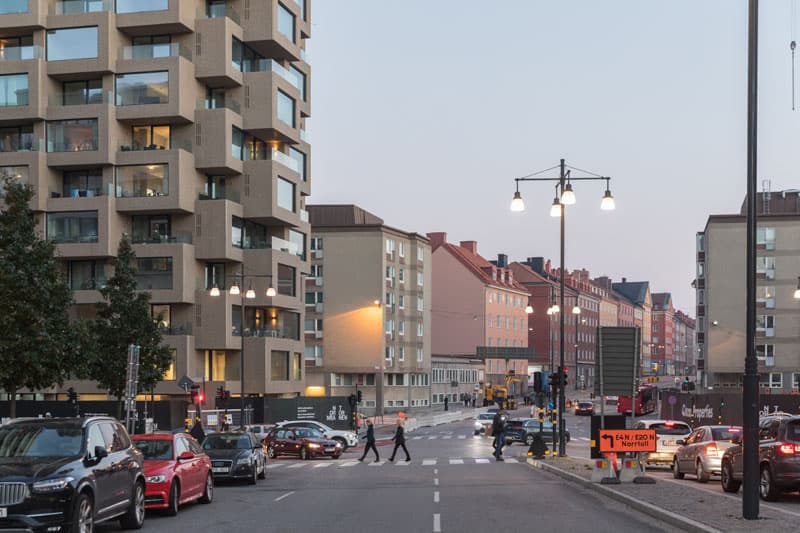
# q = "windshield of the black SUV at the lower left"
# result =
<box><xmin>0</xmin><ymin>424</ymin><xmax>83</xmax><ymax>459</ymax></box>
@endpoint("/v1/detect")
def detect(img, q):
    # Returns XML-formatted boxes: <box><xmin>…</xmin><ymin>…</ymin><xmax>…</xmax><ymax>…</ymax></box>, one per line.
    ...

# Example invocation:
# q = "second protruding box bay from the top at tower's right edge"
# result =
<box><xmin>240</xmin><ymin>69</ymin><xmax>300</xmax><ymax>144</ymax></box>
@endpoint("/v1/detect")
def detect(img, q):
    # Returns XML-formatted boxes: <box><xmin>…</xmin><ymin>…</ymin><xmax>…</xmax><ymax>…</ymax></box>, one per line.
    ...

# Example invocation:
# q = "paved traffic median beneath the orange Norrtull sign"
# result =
<box><xmin>528</xmin><ymin>457</ymin><xmax>798</xmax><ymax>532</ymax></box>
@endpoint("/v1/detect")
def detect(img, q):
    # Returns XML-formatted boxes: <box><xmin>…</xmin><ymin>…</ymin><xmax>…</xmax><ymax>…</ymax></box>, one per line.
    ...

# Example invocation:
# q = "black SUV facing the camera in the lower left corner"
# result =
<box><xmin>0</xmin><ymin>417</ymin><xmax>145</xmax><ymax>532</ymax></box>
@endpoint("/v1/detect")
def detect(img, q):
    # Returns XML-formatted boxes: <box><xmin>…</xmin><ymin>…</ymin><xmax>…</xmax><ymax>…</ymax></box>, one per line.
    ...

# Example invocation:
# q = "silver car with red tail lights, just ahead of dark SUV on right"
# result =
<box><xmin>672</xmin><ymin>426</ymin><xmax>742</xmax><ymax>483</ymax></box>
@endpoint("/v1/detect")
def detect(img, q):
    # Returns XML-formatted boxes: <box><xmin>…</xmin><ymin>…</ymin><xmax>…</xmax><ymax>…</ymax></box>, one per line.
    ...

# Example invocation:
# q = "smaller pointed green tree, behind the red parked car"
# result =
<box><xmin>88</xmin><ymin>235</ymin><xmax>172</xmax><ymax>415</ymax></box>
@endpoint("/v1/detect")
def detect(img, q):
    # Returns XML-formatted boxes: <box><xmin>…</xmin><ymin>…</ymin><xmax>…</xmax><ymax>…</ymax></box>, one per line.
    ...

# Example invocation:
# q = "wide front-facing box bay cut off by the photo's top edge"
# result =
<box><xmin>116</xmin><ymin>0</ymin><xmax>195</xmax><ymax>35</ymax></box>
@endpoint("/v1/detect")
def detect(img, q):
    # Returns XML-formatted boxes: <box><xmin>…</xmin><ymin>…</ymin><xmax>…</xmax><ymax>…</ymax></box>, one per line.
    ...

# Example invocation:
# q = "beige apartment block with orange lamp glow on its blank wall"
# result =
<box><xmin>304</xmin><ymin>205</ymin><xmax>432</xmax><ymax>414</ymax></box>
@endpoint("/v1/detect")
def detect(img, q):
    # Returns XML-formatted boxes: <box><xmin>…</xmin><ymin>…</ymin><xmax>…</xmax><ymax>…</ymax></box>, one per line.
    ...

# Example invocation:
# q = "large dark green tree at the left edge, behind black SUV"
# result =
<box><xmin>0</xmin><ymin>178</ymin><xmax>83</xmax><ymax>417</ymax></box>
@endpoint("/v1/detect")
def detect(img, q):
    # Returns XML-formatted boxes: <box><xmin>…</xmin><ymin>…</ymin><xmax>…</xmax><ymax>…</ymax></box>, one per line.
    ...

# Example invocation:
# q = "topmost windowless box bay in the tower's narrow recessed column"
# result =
<box><xmin>194</xmin><ymin>16</ymin><xmax>242</xmax><ymax>88</ymax></box>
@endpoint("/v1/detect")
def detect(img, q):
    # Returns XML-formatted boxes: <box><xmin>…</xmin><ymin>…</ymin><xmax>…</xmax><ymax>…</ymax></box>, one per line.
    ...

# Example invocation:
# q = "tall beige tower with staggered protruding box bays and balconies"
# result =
<box><xmin>0</xmin><ymin>0</ymin><xmax>311</xmax><ymax>399</ymax></box>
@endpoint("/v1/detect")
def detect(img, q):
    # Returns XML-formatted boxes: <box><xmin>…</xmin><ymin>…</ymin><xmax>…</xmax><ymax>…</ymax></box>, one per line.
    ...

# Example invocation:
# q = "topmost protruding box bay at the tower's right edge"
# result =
<box><xmin>242</xmin><ymin>0</ymin><xmax>308</xmax><ymax>61</ymax></box>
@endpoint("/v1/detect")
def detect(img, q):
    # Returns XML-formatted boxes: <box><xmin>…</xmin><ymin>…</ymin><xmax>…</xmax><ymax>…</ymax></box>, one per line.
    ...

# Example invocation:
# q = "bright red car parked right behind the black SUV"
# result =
<box><xmin>131</xmin><ymin>433</ymin><xmax>214</xmax><ymax>516</ymax></box>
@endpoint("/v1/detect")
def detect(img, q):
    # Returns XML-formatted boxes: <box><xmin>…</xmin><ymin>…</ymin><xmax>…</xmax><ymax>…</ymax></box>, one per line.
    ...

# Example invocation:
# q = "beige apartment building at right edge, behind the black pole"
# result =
<box><xmin>694</xmin><ymin>190</ymin><xmax>800</xmax><ymax>392</ymax></box>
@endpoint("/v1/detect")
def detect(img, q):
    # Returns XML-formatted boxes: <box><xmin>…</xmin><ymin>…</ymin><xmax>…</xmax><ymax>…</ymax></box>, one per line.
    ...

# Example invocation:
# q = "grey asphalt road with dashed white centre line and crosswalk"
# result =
<box><xmin>94</xmin><ymin>412</ymin><xmax>674</xmax><ymax>533</ymax></box>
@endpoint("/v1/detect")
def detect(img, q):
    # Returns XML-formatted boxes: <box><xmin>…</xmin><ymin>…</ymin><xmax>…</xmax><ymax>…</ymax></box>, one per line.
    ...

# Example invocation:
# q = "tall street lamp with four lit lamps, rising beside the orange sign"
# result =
<box><xmin>511</xmin><ymin>159</ymin><xmax>615</xmax><ymax>456</ymax></box>
